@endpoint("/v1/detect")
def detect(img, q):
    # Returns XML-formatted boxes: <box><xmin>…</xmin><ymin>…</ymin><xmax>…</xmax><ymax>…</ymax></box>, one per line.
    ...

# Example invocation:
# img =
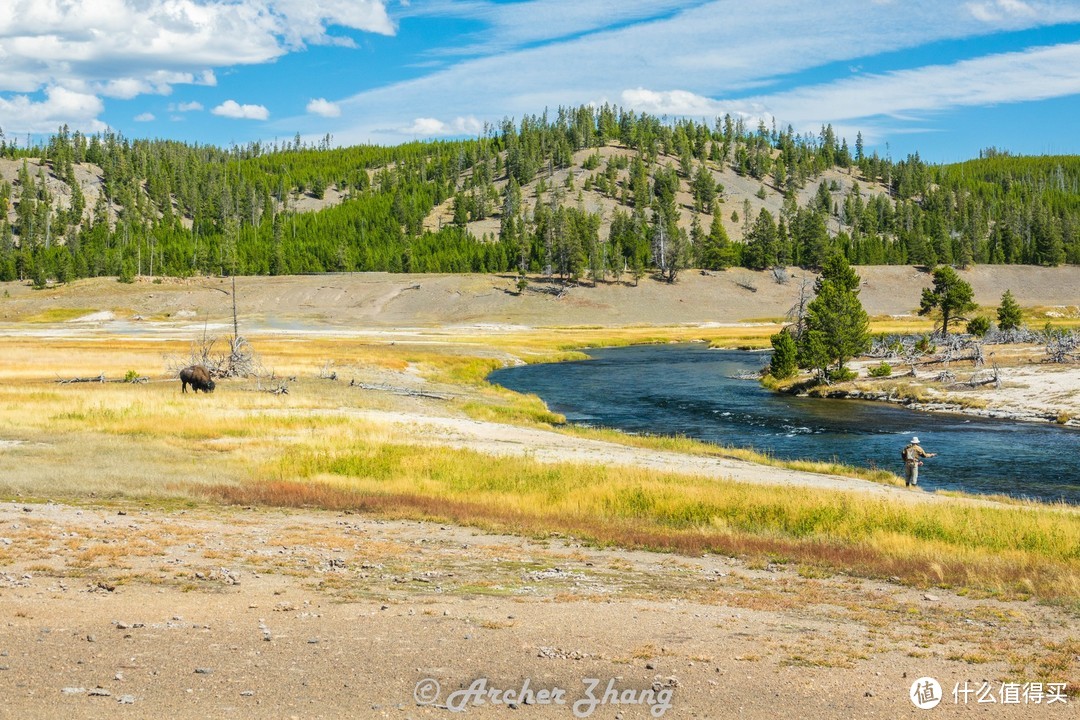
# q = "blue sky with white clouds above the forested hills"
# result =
<box><xmin>0</xmin><ymin>0</ymin><xmax>1080</xmax><ymax>163</ymax></box>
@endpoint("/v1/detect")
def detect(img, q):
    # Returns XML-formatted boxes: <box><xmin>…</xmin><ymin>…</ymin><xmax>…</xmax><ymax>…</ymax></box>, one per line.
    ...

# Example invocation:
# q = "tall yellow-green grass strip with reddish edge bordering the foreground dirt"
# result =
<box><xmin>199</xmin><ymin>440</ymin><xmax>1080</xmax><ymax>609</ymax></box>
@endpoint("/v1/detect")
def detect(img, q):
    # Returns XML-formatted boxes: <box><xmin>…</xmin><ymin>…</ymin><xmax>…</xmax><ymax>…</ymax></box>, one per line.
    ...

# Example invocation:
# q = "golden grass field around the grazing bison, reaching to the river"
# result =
<box><xmin>0</xmin><ymin>326</ymin><xmax>1080</xmax><ymax>612</ymax></box>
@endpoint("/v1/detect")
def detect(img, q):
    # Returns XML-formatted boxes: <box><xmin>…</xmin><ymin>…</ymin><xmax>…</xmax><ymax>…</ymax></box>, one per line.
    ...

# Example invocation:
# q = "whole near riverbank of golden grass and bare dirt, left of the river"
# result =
<box><xmin>0</xmin><ymin>277</ymin><xmax>1080</xmax><ymax>720</ymax></box>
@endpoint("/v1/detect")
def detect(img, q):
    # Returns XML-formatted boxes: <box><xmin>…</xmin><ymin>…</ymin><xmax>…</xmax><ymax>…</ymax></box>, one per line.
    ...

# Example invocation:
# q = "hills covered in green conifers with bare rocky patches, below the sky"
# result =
<box><xmin>0</xmin><ymin>106</ymin><xmax>1080</xmax><ymax>286</ymax></box>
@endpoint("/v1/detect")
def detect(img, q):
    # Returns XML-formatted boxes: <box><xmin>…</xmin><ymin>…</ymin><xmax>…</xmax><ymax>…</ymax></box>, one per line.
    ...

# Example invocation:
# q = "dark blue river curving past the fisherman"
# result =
<box><xmin>490</xmin><ymin>344</ymin><xmax>1080</xmax><ymax>504</ymax></box>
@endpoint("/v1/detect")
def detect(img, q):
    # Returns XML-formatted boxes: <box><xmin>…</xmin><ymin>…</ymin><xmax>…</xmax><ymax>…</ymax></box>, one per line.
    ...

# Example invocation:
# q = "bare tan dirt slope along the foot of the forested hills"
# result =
<box><xmin>0</xmin><ymin>266</ymin><xmax>1080</xmax><ymax>331</ymax></box>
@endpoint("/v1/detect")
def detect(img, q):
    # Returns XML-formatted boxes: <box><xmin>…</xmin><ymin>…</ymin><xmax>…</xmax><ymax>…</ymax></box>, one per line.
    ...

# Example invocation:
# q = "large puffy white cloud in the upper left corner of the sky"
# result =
<box><xmin>0</xmin><ymin>0</ymin><xmax>395</xmax><ymax>132</ymax></box>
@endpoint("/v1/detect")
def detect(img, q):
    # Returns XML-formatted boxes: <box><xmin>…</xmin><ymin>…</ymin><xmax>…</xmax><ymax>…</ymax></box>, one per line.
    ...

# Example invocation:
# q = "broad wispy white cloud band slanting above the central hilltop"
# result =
<box><xmin>315</xmin><ymin>0</ymin><xmax>1080</xmax><ymax>142</ymax></box>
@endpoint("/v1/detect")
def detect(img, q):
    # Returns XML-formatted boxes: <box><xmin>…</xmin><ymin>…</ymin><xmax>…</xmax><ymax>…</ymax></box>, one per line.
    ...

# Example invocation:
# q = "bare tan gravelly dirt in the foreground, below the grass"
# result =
<box><xmin>0</xmin><ymin>503</ymin><xmax>1076</xmax><ymax>719</ymax></box>
